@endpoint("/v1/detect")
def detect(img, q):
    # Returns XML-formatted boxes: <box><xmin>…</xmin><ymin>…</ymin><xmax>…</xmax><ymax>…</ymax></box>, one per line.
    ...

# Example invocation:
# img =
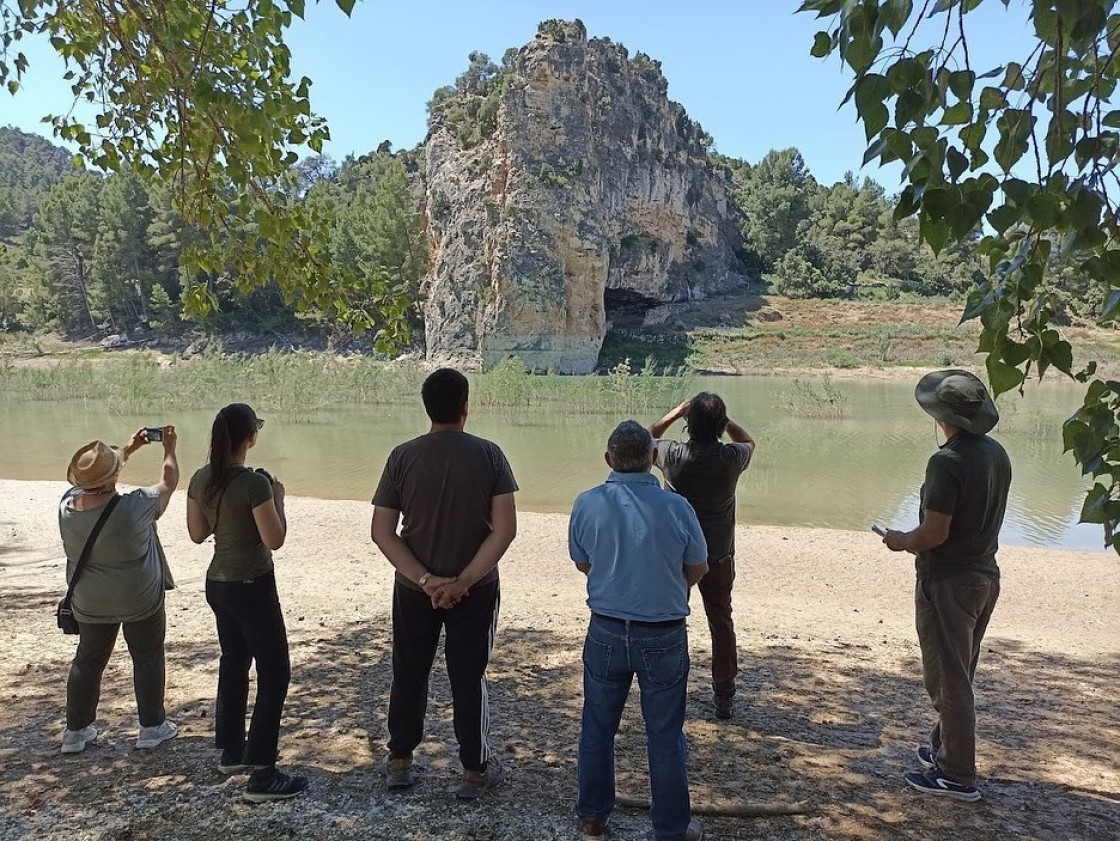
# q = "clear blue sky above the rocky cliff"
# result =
<box><xmin>0</xmin><ymin>0</ymin><xmax>1030</xmax><ymax>190</ymax></box>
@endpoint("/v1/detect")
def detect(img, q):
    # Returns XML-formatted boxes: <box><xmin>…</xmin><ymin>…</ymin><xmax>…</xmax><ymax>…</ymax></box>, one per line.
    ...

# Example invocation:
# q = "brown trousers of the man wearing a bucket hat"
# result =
<box><xmin>914</xmin><ymin>572</ymin><xmax>999</xmax><ymax>785</ymax></box>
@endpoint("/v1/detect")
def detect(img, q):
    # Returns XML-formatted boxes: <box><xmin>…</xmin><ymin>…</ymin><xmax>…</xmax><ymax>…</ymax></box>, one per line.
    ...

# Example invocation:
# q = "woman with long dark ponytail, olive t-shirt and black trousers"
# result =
<box><xmin>187</xmin><ymin>403</ymin><xmax>307</xmax><ymax>803</ymax></box>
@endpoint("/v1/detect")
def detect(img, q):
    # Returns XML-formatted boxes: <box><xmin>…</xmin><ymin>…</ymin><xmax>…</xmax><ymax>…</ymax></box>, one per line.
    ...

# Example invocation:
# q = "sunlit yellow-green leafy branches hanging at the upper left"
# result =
<box><xmin>0</xmin><ymin>0</ymin><xmax>408</xmax><ymax>349</ymax></box>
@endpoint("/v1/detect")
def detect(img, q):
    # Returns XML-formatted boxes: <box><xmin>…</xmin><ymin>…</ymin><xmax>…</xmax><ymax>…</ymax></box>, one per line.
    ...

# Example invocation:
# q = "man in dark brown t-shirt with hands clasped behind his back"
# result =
<box><xmin>371</xmin><ymin>368</ymin><xmax>517</xmax><ymax>800</ymax></box>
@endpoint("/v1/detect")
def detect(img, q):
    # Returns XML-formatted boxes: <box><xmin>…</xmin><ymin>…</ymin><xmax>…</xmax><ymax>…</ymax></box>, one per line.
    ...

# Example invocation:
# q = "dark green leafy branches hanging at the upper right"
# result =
<box><xmin>800</xmin><ymin>0</ymin><xmax>1120</xmax><ymax>551</ymax></box>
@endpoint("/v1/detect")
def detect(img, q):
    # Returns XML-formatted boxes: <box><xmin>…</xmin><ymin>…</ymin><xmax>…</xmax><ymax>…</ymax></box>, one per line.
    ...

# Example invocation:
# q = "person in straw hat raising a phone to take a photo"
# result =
<box><xmin>58</xmin><ymin>427</ymin><xmax>179</xmax><ymax>754</ymax></box>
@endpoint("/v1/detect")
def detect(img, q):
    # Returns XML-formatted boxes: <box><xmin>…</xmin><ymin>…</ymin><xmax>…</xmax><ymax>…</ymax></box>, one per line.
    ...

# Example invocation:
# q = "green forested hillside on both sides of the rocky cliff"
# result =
<box><xmin>0</xmin><ymin>101</ymin><xmax>1100</xmax><ymax>336</ymax></box>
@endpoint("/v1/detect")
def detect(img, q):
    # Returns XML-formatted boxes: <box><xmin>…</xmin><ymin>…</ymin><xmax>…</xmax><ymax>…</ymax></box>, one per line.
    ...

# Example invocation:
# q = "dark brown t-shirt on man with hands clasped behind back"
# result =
<box><xmin>373</xmin><ymin>432</ymin><xmax>517</xmax><ymax>589</ymax></box>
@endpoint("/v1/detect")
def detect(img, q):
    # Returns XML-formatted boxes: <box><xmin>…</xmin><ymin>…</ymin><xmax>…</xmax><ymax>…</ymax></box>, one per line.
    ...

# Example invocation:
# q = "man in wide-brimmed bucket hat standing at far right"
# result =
<box><xmin>883</xmin><ymin>370</ymin><xmax>1011</xmax><ymax>801</ymax></box>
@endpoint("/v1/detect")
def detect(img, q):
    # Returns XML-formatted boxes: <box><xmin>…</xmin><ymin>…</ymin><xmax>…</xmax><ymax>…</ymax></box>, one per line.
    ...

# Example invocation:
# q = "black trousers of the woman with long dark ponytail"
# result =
<box><xmin>206</xmin><ymin>572</ymin><xmax>291</xmax><ymax>765</ymax></box>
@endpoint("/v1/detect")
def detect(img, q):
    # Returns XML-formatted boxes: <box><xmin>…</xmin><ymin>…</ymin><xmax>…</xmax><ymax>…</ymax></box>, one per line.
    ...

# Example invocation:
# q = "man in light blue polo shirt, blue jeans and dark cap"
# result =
<box><xmin>568</xmin><ymin>421</ymin><xmax>708</xmax><ymax>841</ymax></box>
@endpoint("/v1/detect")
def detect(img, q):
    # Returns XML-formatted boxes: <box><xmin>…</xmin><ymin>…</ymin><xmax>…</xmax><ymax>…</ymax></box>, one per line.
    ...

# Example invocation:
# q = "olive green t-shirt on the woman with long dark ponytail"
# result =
<box><xmin>187</xmin><ymin>465</ymin><xmax>272</xmax><ymax>581</ymax></box>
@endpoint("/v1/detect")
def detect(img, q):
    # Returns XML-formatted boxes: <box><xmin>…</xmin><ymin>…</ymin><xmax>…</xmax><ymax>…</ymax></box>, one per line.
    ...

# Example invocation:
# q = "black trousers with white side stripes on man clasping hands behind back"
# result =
<box><xmin>389</xmin><ymin>580</ymin><xmax>501</xmax><ymax>770</ymax></box>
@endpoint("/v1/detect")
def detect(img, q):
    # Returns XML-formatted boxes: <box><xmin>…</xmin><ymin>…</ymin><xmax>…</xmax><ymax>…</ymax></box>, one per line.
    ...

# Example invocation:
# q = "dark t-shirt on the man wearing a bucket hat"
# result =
<box><xmin>915</xmin><ymin>432</ymin><xmax>1011</xmax><ymax>580</ymax></box>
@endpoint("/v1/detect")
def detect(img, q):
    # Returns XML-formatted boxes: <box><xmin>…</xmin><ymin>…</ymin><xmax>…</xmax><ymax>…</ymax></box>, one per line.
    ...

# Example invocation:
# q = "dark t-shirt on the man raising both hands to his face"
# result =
<box><xmin>655</xmin><ymin>440</ymin><xmax>754</xmax><ymax>561</ymax></box>
